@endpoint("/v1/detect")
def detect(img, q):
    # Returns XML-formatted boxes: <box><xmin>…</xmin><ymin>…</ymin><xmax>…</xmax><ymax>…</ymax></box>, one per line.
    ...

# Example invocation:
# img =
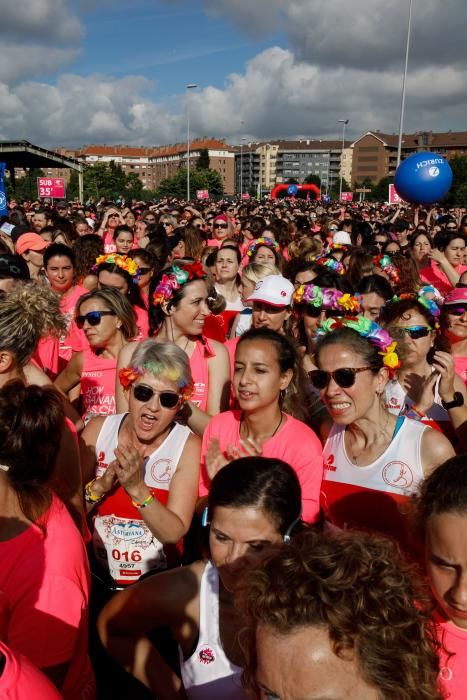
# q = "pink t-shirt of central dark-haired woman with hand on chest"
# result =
<box><xmin>199</xmin><ymin>411</ymin><xmax>323</xmax><ymax>522</ymax></box>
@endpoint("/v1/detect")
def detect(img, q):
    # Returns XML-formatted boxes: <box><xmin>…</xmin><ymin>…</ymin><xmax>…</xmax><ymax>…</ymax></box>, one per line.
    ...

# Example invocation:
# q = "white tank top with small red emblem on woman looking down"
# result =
<box><xmin>179</xmin><ymin>562</ymin><xmax>248</xmax><ymax>700</ymax></box>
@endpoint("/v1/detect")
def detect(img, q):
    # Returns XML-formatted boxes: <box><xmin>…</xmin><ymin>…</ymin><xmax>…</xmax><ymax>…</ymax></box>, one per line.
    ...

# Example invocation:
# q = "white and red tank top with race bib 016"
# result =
<box><xmin>92</xmin><ymin>414</ymin><xmax>191</xmax><ymax>586</ymax></box>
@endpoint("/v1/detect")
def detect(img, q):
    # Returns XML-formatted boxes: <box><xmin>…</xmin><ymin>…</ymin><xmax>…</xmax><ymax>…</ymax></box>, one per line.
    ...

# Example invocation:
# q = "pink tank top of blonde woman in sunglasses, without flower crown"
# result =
<box><xmin>81</xmin><ymin>349</ymin><xmax>117</xmax><ymax>422</ymax></box>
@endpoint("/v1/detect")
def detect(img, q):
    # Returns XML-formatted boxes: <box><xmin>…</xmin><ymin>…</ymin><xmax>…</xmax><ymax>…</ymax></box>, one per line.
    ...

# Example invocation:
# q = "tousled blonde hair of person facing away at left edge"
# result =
<box><xmin>0</xmin><ymin>284</ymin><xmax>67</xmax><ymax>367</ymax></box>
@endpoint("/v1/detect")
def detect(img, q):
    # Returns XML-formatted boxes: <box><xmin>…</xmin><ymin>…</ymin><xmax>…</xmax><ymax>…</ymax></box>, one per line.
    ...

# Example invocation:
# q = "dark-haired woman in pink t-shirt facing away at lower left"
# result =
<box><xmin>0</xmin><ymin>382</ymin><xmax>95</xmax><ymax>700</ymax></box>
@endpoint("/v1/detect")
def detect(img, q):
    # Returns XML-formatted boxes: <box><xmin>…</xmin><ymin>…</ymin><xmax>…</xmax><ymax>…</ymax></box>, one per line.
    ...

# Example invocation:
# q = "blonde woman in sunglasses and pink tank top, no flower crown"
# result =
<box><xmin>55</xmin><ymin>287</ymin><xmax>137</xmax><ymax>421</ymax></box>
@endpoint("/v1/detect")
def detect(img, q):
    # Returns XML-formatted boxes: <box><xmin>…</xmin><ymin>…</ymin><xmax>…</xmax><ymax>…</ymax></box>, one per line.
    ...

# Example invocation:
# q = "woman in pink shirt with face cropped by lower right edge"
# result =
<box><xmin>418</xmin><ymin>455</ymin><xmax>467</xmax><ymax>700</ymax></box>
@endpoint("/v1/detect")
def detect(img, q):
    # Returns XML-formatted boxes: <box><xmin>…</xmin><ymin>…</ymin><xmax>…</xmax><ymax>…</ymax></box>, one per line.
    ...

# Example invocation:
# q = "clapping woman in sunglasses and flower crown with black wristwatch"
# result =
<box><xmin>381</xmin><ymin>287</ymin><xmax>467</xmax><ymax>444</ymax></box>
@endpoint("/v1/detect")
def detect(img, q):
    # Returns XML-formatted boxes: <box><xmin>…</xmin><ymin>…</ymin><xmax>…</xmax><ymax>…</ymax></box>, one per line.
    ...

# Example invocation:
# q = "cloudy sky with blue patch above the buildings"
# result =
<box><xmin>0</xmin><ymin>0</ymin><xmax>467</xmax><ymax>147</ymax></box>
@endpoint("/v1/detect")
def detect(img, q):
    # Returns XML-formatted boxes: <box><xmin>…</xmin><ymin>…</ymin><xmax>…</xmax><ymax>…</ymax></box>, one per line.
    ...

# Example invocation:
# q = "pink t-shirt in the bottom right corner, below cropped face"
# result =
<box><xmin>435</xmin><ymin>615</ymin><xmax>467</xmax><ymax>700</ymax></box>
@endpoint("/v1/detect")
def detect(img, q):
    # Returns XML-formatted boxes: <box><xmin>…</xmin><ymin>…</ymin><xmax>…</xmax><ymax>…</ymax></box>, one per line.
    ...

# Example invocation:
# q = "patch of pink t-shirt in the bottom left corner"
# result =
<box><xmin>0</xmin><ymin>642</ymin><xmax>63</xmax><ymax>700</ymax></box>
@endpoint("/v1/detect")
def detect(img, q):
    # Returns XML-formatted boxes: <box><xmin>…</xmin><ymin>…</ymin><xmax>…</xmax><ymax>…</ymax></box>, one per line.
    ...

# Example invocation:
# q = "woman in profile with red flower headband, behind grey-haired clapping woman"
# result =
<box><xmin>116</xmin><ymin>263</ymin><xmax>230</xmax><ymax>435</ymax></box>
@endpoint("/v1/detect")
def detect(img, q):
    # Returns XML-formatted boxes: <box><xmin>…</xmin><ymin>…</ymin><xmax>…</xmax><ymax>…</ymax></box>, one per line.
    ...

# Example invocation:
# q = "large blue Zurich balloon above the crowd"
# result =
<box><xmin>394</xmin><ymin>151</ymin><xmax>452</xmax><ymax>204</ymax></box>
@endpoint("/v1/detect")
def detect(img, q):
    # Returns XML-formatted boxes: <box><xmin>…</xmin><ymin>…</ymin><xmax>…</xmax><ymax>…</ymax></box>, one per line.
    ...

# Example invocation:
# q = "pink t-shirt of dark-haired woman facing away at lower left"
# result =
<box><xmin>0</xmin><ymin>496</ymin><xmax>95</xmax><ymax>700</ymax></box>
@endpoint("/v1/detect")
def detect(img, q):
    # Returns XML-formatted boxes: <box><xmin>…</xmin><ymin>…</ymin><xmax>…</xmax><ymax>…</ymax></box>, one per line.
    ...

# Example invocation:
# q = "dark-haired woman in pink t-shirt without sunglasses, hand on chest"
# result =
<box><xmin>200</xmin><ymin>328</ymin><xmax>323</xmax><ymax>522</ymax></box>
